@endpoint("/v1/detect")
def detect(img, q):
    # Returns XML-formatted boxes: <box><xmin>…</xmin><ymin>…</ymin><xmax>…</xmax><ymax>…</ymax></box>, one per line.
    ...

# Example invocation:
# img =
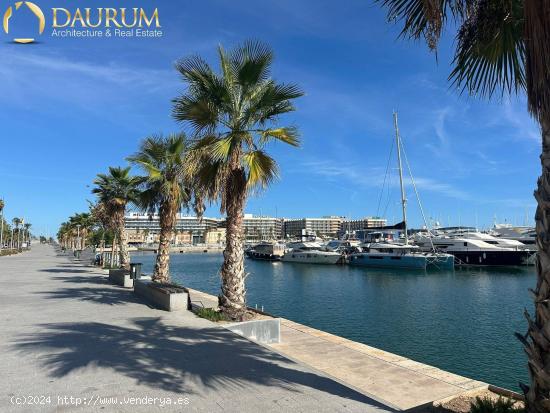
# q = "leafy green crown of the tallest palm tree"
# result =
<box><xmin>172</xmin><ymin>41</ymin><xmax>303</xmax><ymax>212</ymax></box>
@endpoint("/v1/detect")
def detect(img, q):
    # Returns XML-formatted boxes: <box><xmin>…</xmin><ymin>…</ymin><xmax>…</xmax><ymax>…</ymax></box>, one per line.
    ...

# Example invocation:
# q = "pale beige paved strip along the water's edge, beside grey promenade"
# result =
<box><xmin>191</xmin><ymin>290</ymin><xmax>488</xmax><ymax>410</ymax></box>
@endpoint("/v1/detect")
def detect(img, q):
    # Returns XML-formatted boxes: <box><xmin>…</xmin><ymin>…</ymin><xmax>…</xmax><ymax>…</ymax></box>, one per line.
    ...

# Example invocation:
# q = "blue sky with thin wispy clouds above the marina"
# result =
<box><xmin>0</xmin><ymin>0</ymin><xmax>540</xmax><ymax>237</ymax></box>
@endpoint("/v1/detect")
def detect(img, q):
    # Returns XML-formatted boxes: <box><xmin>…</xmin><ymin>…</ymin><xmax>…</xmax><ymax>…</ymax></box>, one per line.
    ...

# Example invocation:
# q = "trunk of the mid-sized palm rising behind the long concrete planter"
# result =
<box><xmin>152</xmin><ymin>201</ymin><xmax>177</xmax><ymax>283</ymax></box>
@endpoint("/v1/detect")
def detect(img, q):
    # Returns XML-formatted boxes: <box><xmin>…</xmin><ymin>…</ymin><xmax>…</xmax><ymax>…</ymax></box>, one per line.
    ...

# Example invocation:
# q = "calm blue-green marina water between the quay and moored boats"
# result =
<box><xmin>133</xmin><ymin>254</ymin><xmax>535</xmax><ymax>389</ymax></box>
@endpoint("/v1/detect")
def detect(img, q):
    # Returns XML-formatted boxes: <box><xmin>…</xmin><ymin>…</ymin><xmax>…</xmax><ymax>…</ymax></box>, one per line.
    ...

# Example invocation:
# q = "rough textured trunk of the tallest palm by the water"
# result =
<box><xmin>219</xmin><ymin>168</ymin><xmax>246</xmax><ymax>320</ymax></box>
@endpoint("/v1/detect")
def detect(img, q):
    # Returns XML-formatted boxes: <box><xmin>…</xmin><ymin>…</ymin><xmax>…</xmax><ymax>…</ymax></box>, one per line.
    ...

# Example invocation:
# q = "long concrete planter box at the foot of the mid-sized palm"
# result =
<box><xmin>134</xmin><ymin>278</ymin><xmax>189</xmax><ymax>311</ymax></box>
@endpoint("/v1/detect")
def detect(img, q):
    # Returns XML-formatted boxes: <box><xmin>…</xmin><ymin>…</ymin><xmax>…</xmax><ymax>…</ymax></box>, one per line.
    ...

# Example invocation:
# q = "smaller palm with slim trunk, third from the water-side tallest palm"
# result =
<box><xmin>92</xmin><ymin>167</ymin><xmax>141</xmax><ymax>269</ymax></box>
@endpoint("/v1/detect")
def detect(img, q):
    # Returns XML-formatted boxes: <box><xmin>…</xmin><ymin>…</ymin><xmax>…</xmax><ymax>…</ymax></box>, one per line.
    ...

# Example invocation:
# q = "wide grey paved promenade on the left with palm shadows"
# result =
<box><xmin>0</xmin><ymin>246</ymin><xmax>391</xmax><ymax>413</ymax></box>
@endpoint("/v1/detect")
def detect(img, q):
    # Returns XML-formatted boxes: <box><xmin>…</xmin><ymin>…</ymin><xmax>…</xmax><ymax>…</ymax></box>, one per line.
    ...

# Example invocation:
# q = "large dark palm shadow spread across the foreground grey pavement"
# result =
<box><xmin>12</xmin><ymin>317</ymin><xmax>387</xmax><ymax>410</ymax></box>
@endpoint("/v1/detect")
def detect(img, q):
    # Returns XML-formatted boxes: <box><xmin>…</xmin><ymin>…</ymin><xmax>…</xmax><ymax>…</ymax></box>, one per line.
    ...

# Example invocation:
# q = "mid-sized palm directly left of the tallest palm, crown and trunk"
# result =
<box><xmin>128</xmin><ymin>134</ymin><xmax>200</xmax><ymax>283</ymax></box>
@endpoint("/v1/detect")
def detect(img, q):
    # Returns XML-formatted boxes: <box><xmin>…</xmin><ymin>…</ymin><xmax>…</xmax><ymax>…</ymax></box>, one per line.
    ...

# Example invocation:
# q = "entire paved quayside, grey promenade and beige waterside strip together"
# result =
<box><xmin>0</xmin><ymin>245</ymin><xmax>496</xmax><ymax>412</ymax></box>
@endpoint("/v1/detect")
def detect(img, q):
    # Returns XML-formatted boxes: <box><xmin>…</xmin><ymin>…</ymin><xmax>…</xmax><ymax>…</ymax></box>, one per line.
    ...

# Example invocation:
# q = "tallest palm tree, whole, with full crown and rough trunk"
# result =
<box><xmin>173</xmin><ymin>41</ymin><xmax>303</xmax><ymax>319</ymax></box>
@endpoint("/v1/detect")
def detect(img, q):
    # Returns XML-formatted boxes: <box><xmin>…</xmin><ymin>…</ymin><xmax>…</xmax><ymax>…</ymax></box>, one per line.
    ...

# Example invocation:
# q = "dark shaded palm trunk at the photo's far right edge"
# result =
<box><xmin>519</xmin><ymin>116</ymin><xmax>550</xmax><ymax>413</ymax></box>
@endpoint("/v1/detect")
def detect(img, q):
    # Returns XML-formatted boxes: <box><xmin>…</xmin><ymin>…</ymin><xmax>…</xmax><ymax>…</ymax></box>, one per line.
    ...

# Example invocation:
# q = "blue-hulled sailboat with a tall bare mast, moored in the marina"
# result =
<box><xmin>348</xmin><ymin>112</ymin><xmax>454</xmax><ymax>269</ymax></box>
